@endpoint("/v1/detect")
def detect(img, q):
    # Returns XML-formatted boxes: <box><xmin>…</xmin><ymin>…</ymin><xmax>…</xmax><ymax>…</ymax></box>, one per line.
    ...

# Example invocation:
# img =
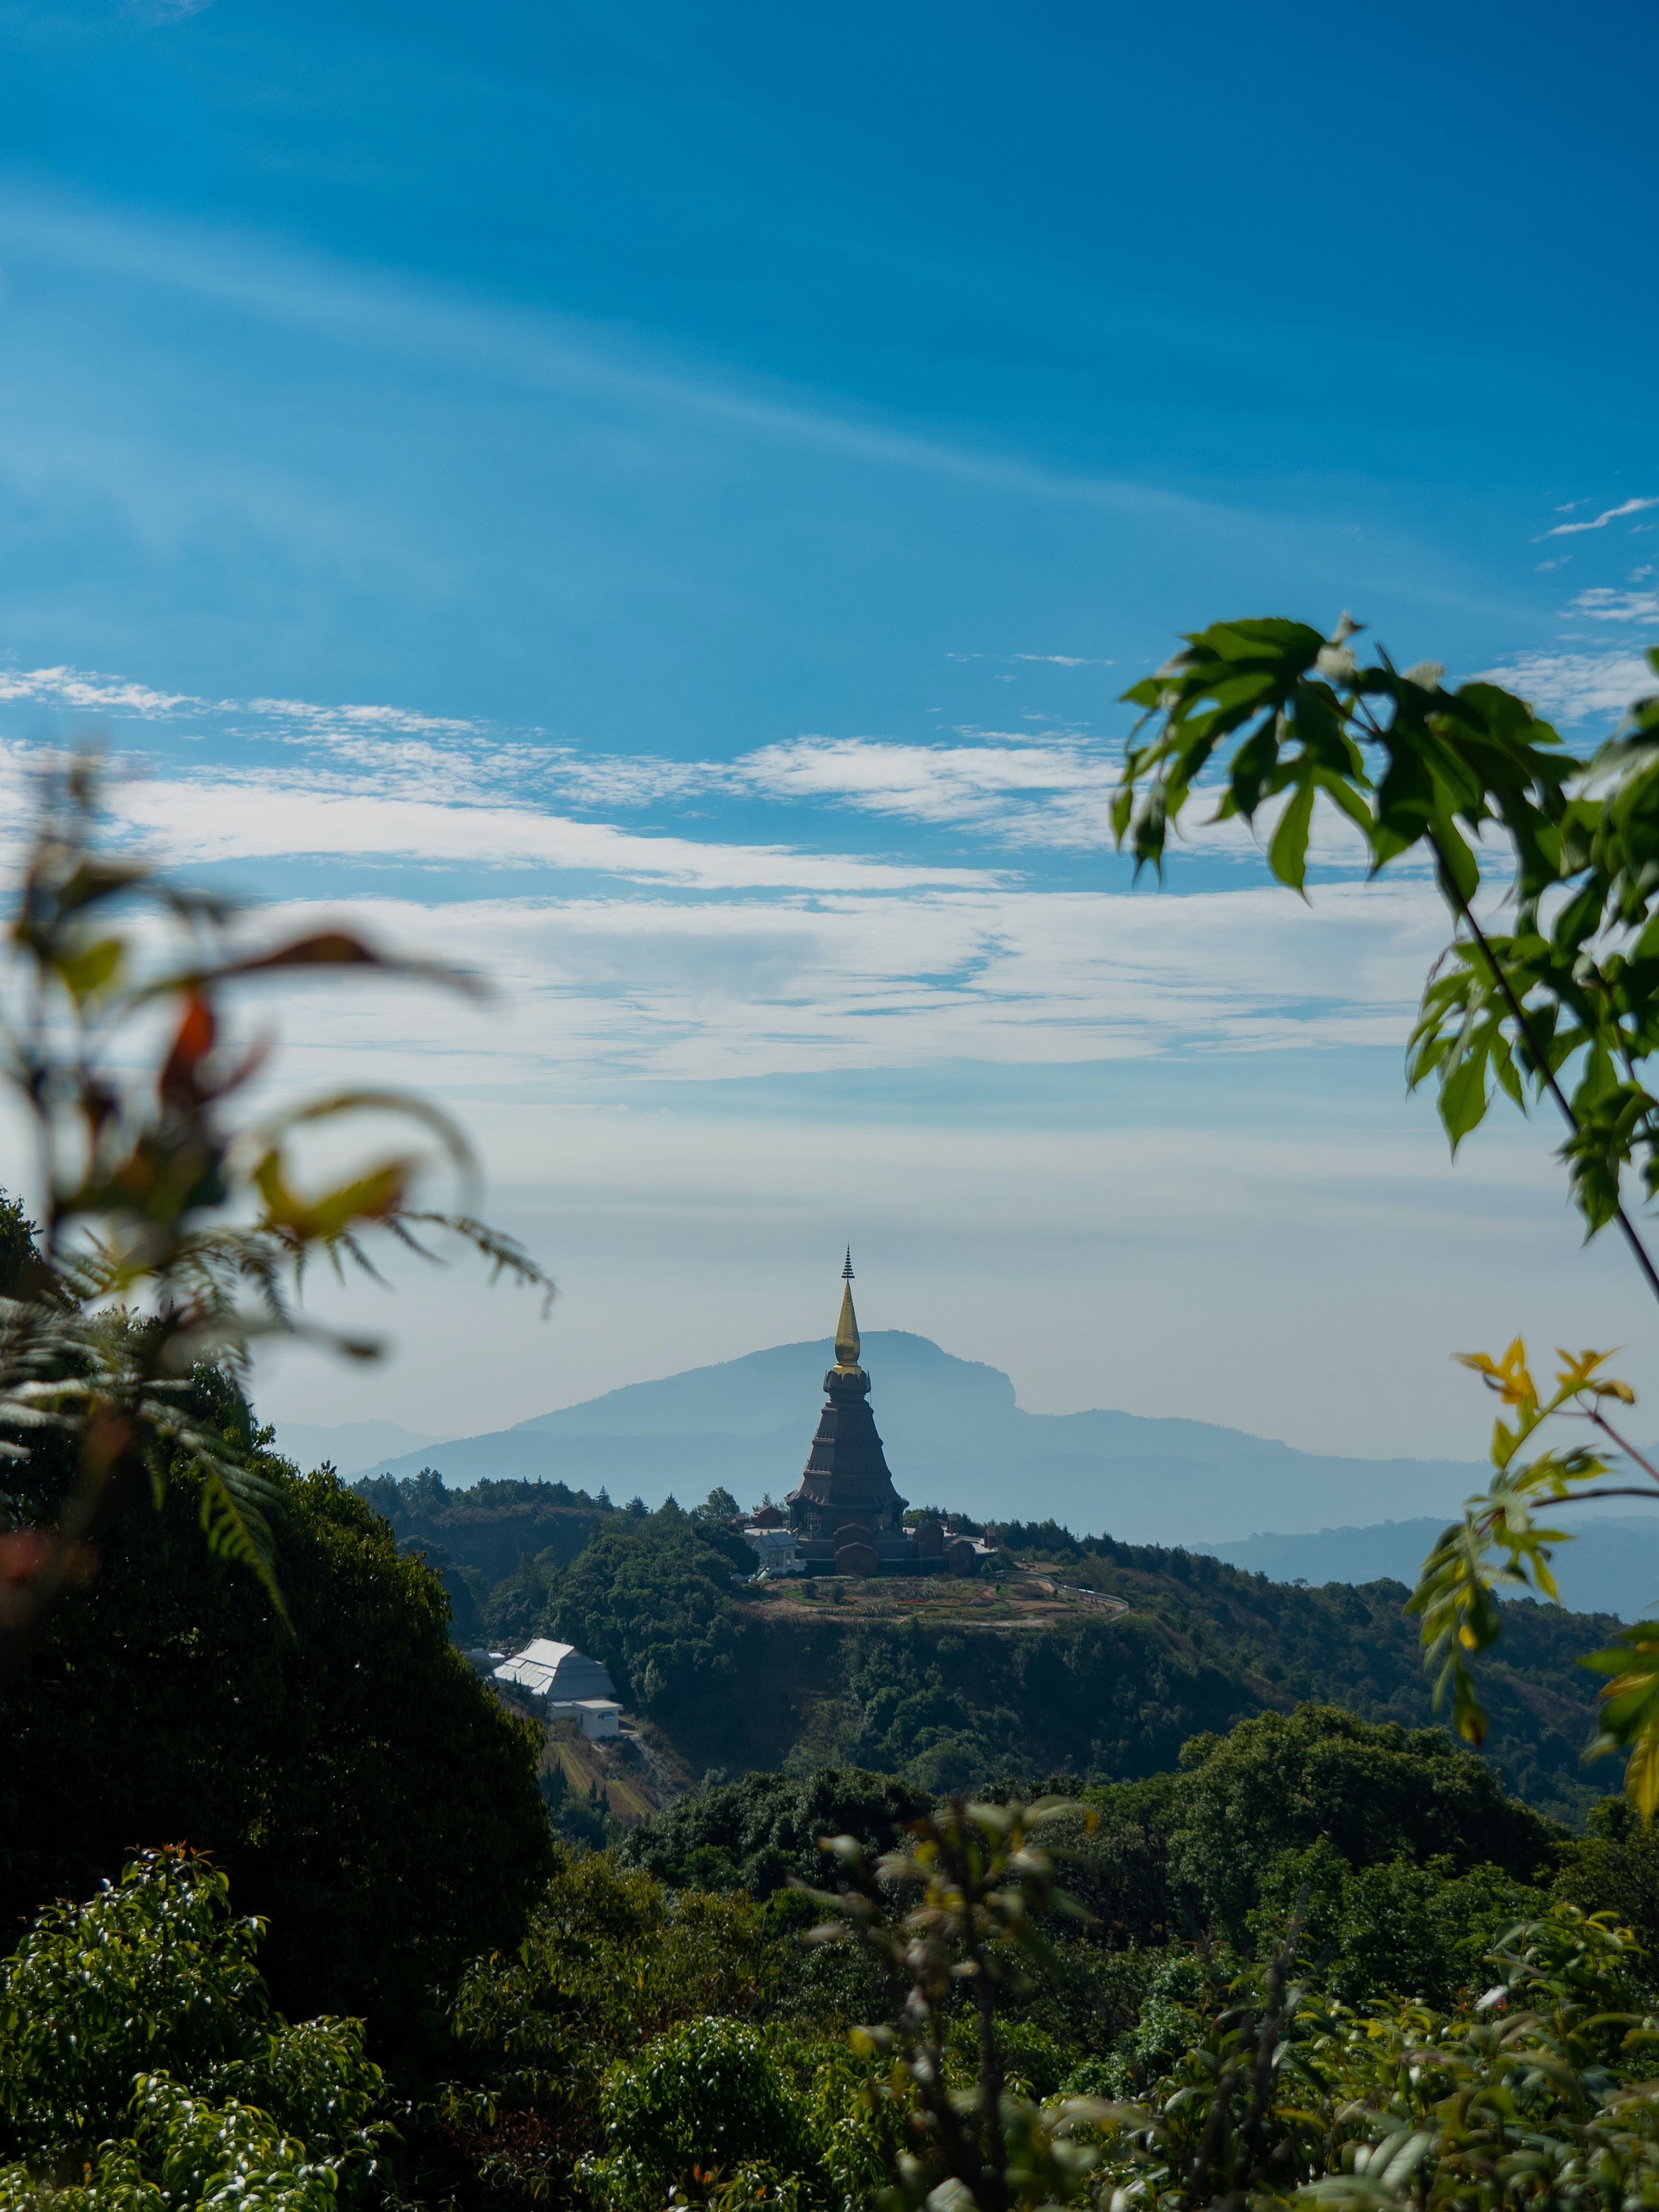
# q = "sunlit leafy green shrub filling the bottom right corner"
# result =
<box><xmin>1083</xmin><ymin>1904</ymin><xmax>1659</xmax><ymax>2212</ymax></box>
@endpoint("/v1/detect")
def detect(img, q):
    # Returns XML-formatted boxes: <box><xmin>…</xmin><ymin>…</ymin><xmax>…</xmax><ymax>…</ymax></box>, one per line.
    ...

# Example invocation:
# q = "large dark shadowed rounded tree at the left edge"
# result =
<box><xmin>0</xmin><ymin>1367</ymin><xmax>551</xmax><ymax>2040</ymax></box>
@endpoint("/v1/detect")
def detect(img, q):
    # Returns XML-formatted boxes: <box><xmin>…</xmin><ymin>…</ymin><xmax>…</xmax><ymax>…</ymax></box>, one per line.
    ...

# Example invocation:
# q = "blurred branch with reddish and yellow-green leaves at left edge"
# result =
<box><xmin>0</xmin><ymin>757</ymin><xmax>553</xmax><ymax>1668</ymax></box>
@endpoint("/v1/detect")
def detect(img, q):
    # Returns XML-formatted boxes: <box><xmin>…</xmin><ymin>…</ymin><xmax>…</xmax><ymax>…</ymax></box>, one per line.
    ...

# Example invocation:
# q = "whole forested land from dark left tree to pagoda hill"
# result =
<box><xmin>0</xmin><ymin>1398</ymin><xmax>1659</xmax><ymax>2212</ymax></box>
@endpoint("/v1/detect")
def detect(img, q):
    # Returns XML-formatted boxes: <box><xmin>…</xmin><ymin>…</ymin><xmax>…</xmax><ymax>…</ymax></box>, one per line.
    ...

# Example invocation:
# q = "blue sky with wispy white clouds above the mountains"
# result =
<box><xmin>0</xmin><ymin>0</ymin><xmax>1659</xmax><ymax>1478</ymax></box>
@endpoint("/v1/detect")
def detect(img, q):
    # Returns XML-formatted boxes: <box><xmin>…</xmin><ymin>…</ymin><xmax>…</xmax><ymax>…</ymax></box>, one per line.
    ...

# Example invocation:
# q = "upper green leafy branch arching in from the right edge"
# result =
<box><xmin>1113</xmin><ymin>615</ymin><xmax>1659</xmax><ymax>1296</ymax></box>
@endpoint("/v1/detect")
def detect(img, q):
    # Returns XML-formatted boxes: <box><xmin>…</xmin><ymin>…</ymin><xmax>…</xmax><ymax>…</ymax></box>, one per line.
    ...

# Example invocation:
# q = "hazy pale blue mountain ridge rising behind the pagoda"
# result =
<box><xmin>354</xmin><ymin>1329</ymin><xmax>1484</xmax><ymax>1544</ymax></box>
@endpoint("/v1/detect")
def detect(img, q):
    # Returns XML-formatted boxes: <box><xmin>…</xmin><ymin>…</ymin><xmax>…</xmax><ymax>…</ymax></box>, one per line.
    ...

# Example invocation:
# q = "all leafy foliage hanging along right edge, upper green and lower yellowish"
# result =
<box><xmin>1113</xmin><ymin>615</ymin><xmax>1659</xmax><ymax>1818</ymax></box>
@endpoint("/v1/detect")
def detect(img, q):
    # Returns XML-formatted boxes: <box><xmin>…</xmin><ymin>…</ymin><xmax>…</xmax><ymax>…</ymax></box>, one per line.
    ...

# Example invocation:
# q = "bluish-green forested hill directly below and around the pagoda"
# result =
<box><xmin>358</xmin><ymin>1473</ymin><xmax>1617</xmax><ymax>1823</ymax></box>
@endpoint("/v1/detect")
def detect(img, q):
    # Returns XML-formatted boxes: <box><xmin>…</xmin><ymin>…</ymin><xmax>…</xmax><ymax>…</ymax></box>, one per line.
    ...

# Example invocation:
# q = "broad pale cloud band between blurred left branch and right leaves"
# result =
<box><xmin>240</xmin><ymin>883</ymin><xmax>1447</xmax><ymax>1095</ymax></box>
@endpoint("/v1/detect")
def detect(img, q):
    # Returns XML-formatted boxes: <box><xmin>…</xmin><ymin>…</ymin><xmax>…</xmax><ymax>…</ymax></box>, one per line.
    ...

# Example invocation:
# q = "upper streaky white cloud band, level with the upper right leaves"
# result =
<box><xmin>0</xmin><ymin>668</ymin><xmax>1365</xmax><ymax>863</ymax></box>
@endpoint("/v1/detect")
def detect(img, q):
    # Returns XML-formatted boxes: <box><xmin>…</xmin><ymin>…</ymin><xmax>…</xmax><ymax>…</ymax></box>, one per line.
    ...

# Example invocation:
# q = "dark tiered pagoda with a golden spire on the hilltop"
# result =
<box><xmin>785</xmin><ymin>1248</ymin><xmax>942</xmax><ymax>1575</ymax></box>
